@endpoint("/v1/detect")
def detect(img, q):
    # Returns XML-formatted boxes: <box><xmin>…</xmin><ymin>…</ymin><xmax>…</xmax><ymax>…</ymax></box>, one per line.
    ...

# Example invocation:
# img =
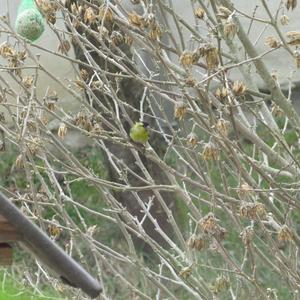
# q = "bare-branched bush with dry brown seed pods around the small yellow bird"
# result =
<box><xmin>0</xmin><ymin>0</ymin><xmax>300</xmax><ymax>299</ymax></box>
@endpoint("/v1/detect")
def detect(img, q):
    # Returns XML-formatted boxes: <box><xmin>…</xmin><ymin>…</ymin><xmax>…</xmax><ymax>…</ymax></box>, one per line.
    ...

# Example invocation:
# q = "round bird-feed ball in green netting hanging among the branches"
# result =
<box><xmin>16</xmin><ymin>0</ymin><xmax>45</xmax><ymax>42</ymax></box>
